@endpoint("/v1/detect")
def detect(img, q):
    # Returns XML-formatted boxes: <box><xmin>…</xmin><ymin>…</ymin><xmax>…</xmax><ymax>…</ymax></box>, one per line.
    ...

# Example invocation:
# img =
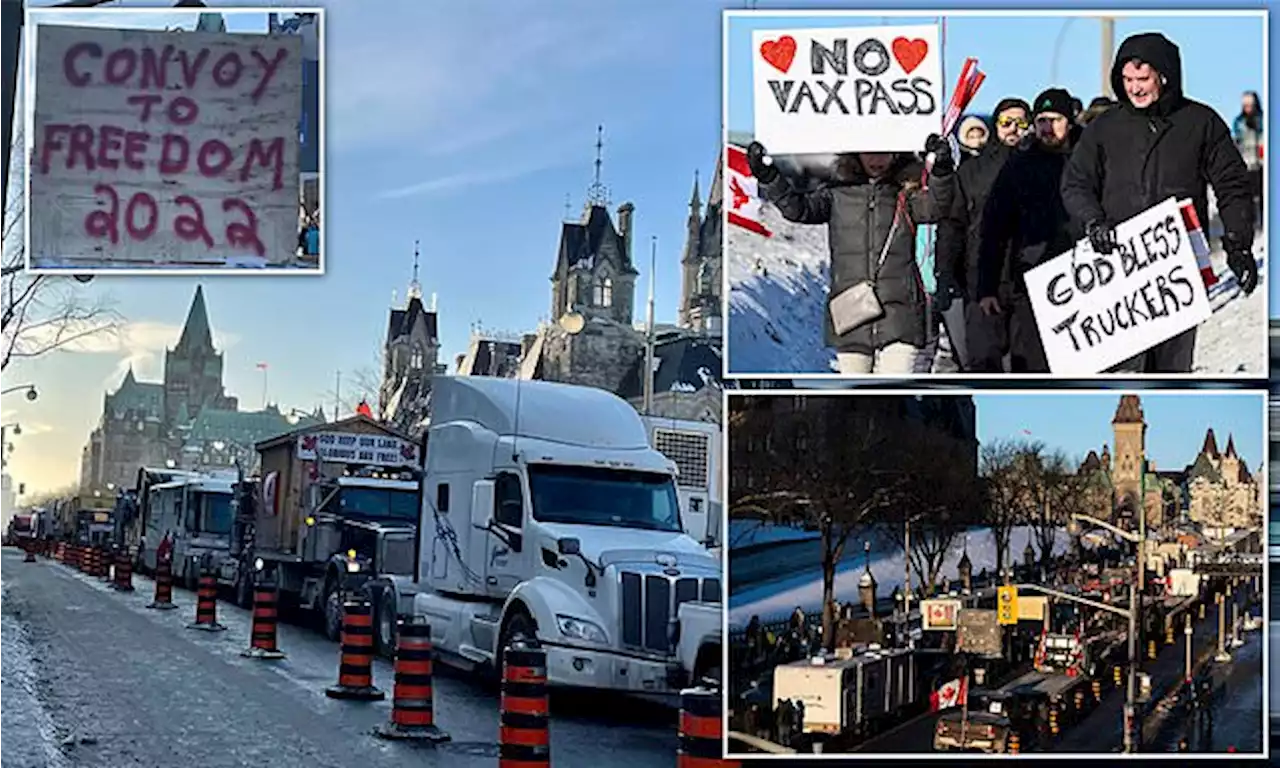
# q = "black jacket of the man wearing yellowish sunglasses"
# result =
<box><xmin>929</xmin><ymin>141</ymin><xmax>1012</xmax><ymax>301</ymax></box>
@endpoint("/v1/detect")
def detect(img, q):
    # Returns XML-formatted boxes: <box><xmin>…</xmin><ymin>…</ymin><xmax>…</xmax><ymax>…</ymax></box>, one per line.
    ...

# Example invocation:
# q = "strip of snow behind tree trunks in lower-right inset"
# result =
<box><xmin>728</xmin><ymin>527</ymin><xmax>1069</xmax><ymax>627</ymax></box>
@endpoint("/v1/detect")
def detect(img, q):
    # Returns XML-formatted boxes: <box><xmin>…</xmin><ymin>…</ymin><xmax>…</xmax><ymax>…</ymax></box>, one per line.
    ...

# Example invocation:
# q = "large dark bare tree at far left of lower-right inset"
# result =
<box><xmin>730</xmin><ymin>396</ymin><xmax>916</xmax><ymax>648</ymax></box>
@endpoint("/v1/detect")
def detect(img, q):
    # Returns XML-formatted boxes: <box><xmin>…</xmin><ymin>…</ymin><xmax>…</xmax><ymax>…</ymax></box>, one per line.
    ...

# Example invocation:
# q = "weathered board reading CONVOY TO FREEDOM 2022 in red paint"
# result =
<box><xmin>28</xmin><ymin>24</ymin><xmax>302</xmax><ymax>269</ymax></box>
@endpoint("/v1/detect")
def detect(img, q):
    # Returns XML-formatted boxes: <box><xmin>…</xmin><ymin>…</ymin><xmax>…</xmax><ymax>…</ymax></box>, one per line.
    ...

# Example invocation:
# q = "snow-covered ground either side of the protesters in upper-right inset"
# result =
<box><xmin>724</xmin><ymin>198</ymin><xmax>1270</xmax><ymax>375</ymax></box>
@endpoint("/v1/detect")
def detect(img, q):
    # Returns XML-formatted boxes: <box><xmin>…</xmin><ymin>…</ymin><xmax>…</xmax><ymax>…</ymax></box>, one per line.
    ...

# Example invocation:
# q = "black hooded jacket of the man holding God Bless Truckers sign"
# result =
<box><xmin>1062</xmin><ymin>33</ymin><xmax>1254</xmax><ymax>247</ymax></box>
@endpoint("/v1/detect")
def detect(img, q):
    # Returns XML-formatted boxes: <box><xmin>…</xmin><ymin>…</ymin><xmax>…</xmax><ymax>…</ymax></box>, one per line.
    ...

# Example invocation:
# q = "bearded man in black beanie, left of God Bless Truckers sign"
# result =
<box><xmin>978</xmin><ymin>88</ymin><xmax>1075</xmax><ymax>374</ymax></box>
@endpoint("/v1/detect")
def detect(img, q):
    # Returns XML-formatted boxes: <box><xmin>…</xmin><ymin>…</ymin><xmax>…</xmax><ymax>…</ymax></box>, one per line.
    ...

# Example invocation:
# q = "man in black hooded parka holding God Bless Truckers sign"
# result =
<box><xmin>1062</xmin><ymin>32</ymin><xmax>1258</xmax><ymax>374</ymax></box>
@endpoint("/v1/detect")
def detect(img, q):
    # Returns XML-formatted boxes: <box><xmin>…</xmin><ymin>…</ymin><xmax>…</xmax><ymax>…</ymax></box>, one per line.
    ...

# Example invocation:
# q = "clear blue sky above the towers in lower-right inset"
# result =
<box><xmin>973</xmin><ymin>392</ymin><xmax>1265</xmax><ymax>470</ymax></box>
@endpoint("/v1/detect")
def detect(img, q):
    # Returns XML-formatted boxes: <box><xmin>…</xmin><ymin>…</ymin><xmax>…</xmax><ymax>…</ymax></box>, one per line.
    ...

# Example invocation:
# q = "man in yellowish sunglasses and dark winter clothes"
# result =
<box><xmin>929</xmin><ymin>99</ymin><xmax>1030</xmax><ymax>374</ymax></box>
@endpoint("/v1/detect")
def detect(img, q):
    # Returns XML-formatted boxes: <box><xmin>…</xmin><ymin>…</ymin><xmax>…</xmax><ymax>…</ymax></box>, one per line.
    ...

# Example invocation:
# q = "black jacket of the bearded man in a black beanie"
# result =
<box><xmin>978</xmin><ymin>142</ymin><xmax>1075</xmax><ymax>298</ymax></box>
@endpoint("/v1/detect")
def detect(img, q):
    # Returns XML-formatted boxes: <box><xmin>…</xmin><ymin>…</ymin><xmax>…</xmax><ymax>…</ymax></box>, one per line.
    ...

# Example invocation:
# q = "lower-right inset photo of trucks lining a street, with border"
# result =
<box><xmin>722</xmin><ymin>389</ymin><xmax>1271</xmax><ymax>762</ymax></box>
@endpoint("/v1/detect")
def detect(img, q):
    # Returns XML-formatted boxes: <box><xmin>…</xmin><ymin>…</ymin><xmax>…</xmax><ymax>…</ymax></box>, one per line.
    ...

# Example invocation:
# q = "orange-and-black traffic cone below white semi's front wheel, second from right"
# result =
<box><xmin>498</xmin><ymin>640</ymin><xmax>552</xmax><ymax>768</ymax></box>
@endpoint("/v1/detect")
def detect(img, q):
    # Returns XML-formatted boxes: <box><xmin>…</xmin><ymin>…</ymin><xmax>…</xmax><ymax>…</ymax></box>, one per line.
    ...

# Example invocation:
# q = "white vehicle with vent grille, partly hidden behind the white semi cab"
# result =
<box><xmin>641</xmin><ymin>416</ymin><xmax>723</xmax><ymax>549</ymax></box>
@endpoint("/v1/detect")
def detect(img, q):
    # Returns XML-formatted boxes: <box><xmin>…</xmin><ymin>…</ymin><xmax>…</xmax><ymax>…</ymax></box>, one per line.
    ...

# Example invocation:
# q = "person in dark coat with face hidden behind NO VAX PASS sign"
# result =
<box><xmin>746</xmin><ymin>143</ymin><xmax>951</xmax><ymax>374</ymax></box>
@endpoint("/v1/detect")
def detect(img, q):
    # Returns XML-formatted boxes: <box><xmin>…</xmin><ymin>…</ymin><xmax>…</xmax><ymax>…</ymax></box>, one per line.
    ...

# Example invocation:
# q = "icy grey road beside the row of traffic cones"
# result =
<box><xmin>0</xmin><ymin>549</ymin><xmax>676</xmax><ymax>768</ymax></box>
